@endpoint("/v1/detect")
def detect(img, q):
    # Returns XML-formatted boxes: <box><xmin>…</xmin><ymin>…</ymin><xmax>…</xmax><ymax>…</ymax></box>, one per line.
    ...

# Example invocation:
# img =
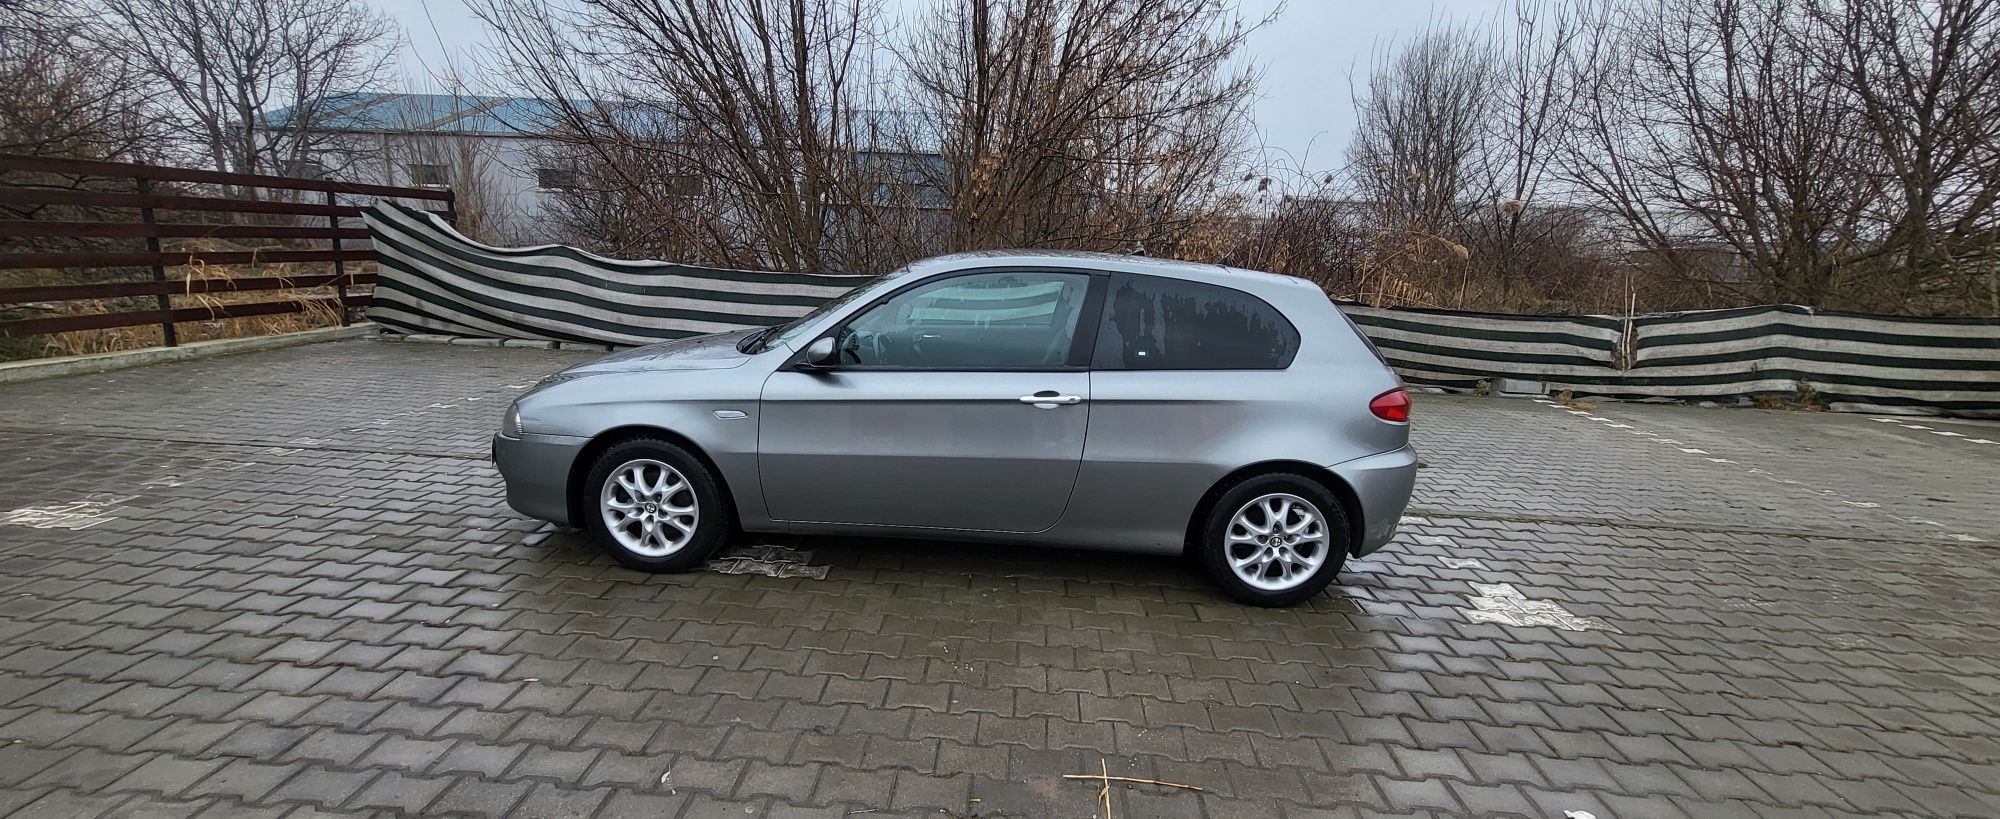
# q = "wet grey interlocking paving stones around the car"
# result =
<box><xmin>0</xmin><ymin>342</ymin><xmax>2000</xmax><ymax>817</ymax></box>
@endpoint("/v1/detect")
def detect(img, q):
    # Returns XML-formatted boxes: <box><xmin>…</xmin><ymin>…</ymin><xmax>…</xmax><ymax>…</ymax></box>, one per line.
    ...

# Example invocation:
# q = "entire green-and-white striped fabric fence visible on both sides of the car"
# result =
<box><xmin>366</xmin><ymin>202</ymin><xmax>2000</xmax><ymax>417</ymax></box>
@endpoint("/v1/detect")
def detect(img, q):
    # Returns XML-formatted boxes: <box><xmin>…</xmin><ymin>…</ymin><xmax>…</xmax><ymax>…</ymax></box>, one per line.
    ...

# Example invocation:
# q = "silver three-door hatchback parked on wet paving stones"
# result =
<box><xmin>494</xmin><ymin>252</ymin><xmax>1416</xmax><ymax>605</ymax></box>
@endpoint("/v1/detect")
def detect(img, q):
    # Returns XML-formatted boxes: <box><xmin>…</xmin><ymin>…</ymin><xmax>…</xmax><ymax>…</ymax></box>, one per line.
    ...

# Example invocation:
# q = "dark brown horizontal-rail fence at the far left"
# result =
<box><xmin>0</xmin><ymin>154</ymin><xmax>456</xmax><ymax>346</ymax></box>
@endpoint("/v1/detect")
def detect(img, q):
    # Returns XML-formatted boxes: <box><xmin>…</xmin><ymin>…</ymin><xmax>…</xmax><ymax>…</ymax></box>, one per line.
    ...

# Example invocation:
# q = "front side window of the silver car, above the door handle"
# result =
<box><xmin>836</xmin><ymin>272</ymin><xmax>1090</xmax><ymax>370</ymax></box>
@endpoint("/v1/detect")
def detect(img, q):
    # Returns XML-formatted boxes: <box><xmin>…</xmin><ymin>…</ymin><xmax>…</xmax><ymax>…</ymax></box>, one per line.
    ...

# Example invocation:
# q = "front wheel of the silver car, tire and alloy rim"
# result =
<box><xmin>578</xmin><ymin>437</ymin><xmax>734</xmax><ymax>571</ymax></box>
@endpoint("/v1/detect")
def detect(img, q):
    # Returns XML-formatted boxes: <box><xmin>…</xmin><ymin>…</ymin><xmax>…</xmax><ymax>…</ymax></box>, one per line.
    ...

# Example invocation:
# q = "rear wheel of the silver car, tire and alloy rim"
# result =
<box><xmin>1194</xmin><ymin>473</ymin><xmax>1354</xmax><ymax>607</ymax></box>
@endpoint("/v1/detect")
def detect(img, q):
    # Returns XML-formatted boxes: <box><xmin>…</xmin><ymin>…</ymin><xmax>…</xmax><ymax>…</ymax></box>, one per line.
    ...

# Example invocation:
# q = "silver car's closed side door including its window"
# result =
<box><xmin>758</xmin><ymin>270</ymin><xmax>1102</xmax><ymax>531</ymax></box>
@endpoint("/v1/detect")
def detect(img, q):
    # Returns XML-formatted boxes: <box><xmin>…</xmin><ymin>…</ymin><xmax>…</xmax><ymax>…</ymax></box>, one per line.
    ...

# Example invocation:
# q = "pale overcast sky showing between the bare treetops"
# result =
<box><xmin>368</xmin><ymin>0</ymin><xmax>1510</xmax><ymax>172</ymax></box>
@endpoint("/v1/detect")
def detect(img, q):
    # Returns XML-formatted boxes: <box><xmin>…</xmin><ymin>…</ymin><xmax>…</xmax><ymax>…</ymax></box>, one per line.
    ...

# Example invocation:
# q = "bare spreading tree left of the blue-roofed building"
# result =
<box><xmin>94</xmin><ymin>0</ymin><xmax>396</xmax><ymax>181</ymax></box>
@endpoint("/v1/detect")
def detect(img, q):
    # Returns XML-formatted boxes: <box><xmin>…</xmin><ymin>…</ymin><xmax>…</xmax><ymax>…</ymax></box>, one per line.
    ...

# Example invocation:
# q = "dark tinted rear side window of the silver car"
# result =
<box><xmin>1092</xmin><ymin>274</ymin><xmax>1298</xmax><ymax>370</ymax></box>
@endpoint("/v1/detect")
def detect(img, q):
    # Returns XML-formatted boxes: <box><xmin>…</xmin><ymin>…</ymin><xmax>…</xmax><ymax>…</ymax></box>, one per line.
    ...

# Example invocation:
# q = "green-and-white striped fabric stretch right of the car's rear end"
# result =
<box><xmin>1342</xmin><ymin>304</ymin><xmax>2000</xmax><ymax>417</ymax></box>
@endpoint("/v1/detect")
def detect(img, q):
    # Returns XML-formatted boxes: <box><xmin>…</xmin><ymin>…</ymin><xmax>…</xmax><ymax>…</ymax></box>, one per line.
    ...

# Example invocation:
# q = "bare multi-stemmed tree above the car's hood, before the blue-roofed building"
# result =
<box><xmin>472</xmin><ymin>0</ymin><xmax>900</xmax><ymax>270</ymax></box>
